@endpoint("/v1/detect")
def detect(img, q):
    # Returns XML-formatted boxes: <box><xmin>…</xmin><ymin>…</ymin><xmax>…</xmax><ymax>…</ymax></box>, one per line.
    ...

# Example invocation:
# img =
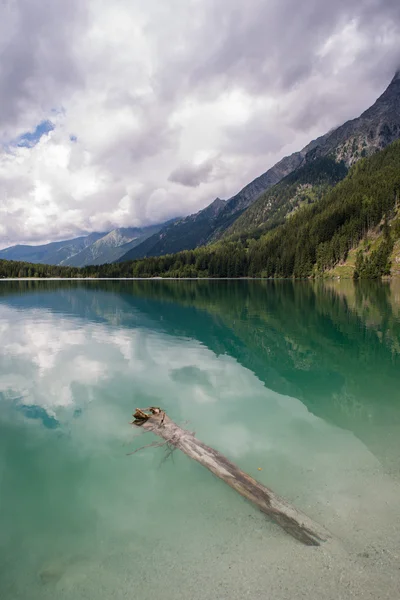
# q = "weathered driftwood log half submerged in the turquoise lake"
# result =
<box><xmin>132</xmin><ymin>407</ymin><xmax>329</xmax><ymax>546</ymax></box>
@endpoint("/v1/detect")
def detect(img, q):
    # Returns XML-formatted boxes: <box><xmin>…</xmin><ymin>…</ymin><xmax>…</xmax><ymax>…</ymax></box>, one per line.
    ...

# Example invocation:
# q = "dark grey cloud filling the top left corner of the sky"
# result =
<box><xmin>0</xmin><ymin>0</ymin><xmax>86</xmax><ymax>141</ymax></box>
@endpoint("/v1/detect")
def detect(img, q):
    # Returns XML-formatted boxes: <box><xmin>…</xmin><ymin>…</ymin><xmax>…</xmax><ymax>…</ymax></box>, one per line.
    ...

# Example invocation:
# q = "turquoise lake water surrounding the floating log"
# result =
<box><xmin>0</xmin><ymin>281</ymin><xmax>400</xmax><ymax>600</ymax></box>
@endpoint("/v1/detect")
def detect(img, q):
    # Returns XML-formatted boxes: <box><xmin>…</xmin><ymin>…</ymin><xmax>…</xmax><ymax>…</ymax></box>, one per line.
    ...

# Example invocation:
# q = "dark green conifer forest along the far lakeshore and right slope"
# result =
<box><xmin>0</xmin><ymin>141</ymin><xmax>400</xmax><ymax>278</ymax></box>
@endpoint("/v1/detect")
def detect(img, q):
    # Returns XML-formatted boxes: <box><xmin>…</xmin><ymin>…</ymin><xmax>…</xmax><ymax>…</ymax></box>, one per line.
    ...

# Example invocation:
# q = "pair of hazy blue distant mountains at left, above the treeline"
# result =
<box><xmin>0</xmin><ymin>223</ymin><xmax>165</xmax><ymax>267</ymax></box>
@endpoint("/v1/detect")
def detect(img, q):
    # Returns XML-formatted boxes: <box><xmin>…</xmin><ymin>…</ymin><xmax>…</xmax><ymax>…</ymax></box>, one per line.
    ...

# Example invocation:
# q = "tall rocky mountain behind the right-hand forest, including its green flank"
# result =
<box><xmin>119</xmin><ymin>71</ymin><xmax>400</xmax><ymax>261</ymax></box>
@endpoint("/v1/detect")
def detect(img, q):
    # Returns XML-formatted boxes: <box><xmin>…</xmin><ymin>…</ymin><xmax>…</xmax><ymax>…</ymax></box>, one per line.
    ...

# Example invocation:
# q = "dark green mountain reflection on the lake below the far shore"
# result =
<box><xmin>0</xmin><ymin>280</ymin><xmax>400</xmax><ymax>464</ymax></box>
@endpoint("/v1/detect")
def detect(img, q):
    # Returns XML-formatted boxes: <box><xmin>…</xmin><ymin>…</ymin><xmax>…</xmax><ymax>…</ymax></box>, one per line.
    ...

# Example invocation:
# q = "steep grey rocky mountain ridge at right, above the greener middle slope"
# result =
<box><xmin>121</xmin><ymin>68</ymin><xmax>400</xmax><ymax>260</ymax></box>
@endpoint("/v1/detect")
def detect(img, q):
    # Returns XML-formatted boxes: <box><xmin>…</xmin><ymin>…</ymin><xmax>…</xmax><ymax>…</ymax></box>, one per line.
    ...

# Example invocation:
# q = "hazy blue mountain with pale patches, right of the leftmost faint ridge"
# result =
<box><xmin>60</xmin><ymin>225</ymin><xmax>162</xmax><ymax>267</ymax></box>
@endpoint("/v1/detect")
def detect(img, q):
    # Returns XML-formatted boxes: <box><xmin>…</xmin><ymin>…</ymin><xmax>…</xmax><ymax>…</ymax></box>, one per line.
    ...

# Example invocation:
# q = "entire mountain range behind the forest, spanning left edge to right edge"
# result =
<box><xmin>0</xmin><ymin>71</ymin><xmax>400</xmax><ymax>267</ymax></box>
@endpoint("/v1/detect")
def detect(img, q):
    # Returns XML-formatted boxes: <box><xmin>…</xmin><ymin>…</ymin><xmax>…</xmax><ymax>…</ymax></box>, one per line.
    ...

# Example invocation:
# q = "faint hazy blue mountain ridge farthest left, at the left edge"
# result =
<box><xmin>0</xmin><ymin>233</ymin><xmax>105</xmax><ymax>265</ymax></box>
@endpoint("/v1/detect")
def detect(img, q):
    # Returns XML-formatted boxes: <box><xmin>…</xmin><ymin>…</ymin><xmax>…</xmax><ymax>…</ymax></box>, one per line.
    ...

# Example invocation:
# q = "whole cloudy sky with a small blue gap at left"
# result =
<box><xmin>0</xmin><ymin>0</ymin><xmax>400</xmax><ymax>247</ymax></box>
